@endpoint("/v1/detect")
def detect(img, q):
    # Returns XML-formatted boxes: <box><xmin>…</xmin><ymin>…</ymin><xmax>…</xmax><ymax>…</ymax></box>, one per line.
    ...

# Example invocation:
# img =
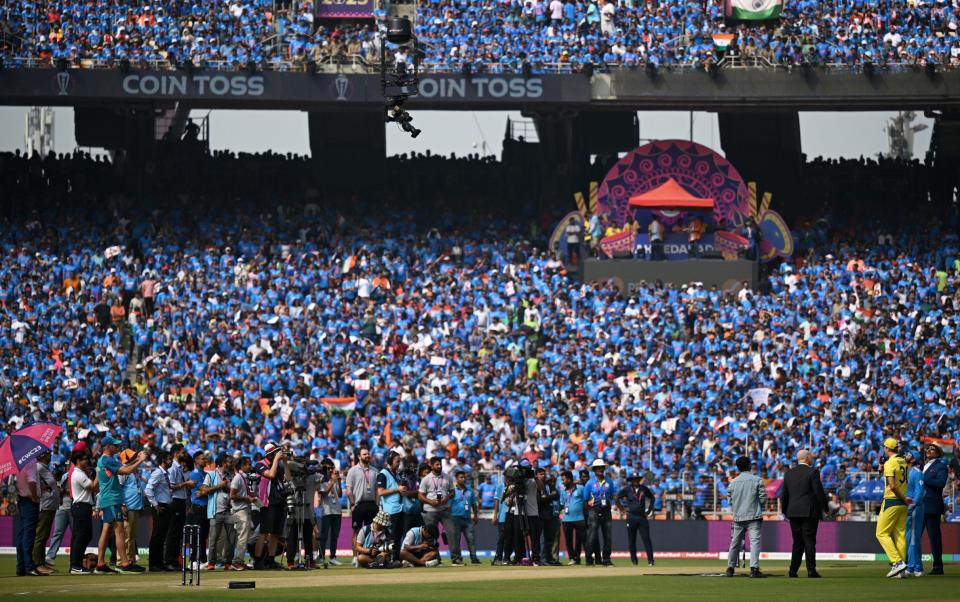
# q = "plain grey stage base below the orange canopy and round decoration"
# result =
<box><xmin>580</xmin><ymin>259</ymin><xmax>760</xmax><ymax>295</ymax></box>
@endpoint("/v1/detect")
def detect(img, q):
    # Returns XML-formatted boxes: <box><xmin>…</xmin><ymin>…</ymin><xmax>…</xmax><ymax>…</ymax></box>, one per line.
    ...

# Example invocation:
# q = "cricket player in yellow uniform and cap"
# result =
<box><xmin>877</xmin><ymin>438</ymin><xmax>913</xmax><ymax>577</ymax></box>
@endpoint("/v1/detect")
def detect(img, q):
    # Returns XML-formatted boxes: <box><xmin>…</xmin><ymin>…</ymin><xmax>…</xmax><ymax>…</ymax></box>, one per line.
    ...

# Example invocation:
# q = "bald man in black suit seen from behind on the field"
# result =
<box><xmin>780</xmin><ymin>449</ymin><xmax>828</xmax><ymax>578</ymax></box>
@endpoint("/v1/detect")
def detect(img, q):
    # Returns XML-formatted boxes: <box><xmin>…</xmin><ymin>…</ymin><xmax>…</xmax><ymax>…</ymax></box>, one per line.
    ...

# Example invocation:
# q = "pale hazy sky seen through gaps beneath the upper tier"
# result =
<box><xmin>0</xmin><ymin>107</ymin><xmax>933</xmax><ymax>158</ymax></box>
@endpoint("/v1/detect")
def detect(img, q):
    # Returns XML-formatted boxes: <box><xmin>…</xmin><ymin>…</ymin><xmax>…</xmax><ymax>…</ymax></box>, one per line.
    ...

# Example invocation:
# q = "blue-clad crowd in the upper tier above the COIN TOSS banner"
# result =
<box><xmin>0</xmin><ymin>0</ymin><xmax>960</xmax><ymax>72</ymax></box>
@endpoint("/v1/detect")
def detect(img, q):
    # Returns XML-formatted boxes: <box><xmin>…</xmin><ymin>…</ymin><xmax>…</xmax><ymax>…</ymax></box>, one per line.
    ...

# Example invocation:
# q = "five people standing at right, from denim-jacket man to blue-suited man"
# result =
<box><xmin>726</xmin><ymin>438</ymin><xmax>948</xmax><ymax>578</ymax></box>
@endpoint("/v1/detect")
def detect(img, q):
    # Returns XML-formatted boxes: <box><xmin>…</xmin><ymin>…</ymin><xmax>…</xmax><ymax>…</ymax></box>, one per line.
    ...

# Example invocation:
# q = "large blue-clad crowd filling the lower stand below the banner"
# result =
<box><xmin>0</xmin><ymin>146</ymin><xmax>960</xmax><ymax>520</ymax></box>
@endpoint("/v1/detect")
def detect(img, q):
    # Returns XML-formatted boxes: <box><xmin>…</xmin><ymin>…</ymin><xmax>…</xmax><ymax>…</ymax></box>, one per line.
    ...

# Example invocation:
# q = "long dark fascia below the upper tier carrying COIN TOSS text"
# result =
<box><xmin>0</xmin><ymin>68</ymin><xmax>960</xmax><ymax>112</ymax></box>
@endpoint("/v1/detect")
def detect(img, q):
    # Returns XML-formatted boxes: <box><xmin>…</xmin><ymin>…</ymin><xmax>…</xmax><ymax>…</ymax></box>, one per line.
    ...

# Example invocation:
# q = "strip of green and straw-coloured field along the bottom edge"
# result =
<box><xmin>0</xmin><ymin>556</ymin><xmax>960</xmax><ymax>602</ymax></box>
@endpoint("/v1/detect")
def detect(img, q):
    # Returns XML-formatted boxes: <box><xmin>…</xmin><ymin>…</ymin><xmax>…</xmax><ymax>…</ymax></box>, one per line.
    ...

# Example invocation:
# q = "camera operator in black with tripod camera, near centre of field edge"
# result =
<box><xmin>503</xmin><ymin>458</ymin><xmax>541</xmax><ymax>565</ymax></box>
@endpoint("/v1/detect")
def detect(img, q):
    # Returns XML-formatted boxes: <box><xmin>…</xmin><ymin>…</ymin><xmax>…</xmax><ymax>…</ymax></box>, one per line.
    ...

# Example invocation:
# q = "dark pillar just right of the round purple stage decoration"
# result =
<box><xmin>718</xmin><ymin>111</ymin><xmax>804</xmax><ymax>215</ymax></box>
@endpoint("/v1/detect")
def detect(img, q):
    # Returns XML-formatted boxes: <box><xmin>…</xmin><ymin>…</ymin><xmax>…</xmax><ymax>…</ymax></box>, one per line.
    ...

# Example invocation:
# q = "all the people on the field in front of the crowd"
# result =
<box><xmin>16</xmin><ymin>435</ymin><xmax>948</xmax><ymax>578</ymax></box>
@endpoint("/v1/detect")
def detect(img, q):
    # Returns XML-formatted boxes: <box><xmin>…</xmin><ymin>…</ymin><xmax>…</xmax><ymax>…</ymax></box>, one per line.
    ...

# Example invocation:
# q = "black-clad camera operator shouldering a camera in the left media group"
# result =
<box><xmin>253</xmin><ymin>441</ymin><xmax>287</xmax><ymax>570</ymax></box>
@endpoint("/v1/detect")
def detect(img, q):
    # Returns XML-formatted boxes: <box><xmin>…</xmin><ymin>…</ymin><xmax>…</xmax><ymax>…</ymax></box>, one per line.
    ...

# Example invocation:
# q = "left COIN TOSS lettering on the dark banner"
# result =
<box><xmin>123</xmin><ymin>73</ymin><xmax>264</xmax><ymax>97</ymax></box>
